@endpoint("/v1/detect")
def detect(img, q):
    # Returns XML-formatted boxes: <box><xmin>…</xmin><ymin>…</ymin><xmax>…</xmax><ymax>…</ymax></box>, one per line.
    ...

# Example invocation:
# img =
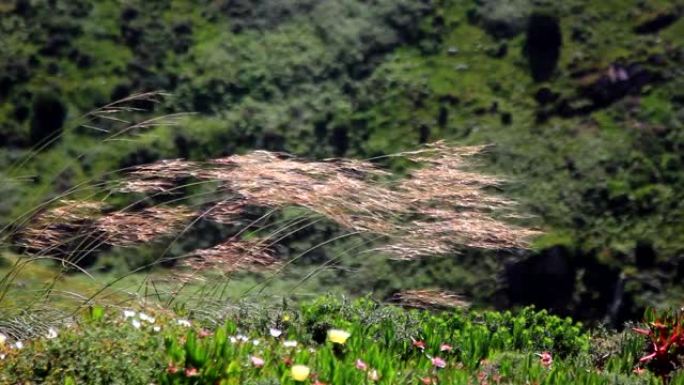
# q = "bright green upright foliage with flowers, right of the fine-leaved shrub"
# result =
<box><xmin>161</xmin><ymin>297</ymin><xmax>592</xmax><ymax>384</ymax></box>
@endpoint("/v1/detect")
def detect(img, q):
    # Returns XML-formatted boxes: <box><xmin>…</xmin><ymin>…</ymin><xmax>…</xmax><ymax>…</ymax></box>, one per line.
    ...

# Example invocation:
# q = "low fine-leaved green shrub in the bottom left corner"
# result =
<box><xmin>0</xmin><ymin>308</ymin><xmax>170</xmax><ymax>385</ymax></box>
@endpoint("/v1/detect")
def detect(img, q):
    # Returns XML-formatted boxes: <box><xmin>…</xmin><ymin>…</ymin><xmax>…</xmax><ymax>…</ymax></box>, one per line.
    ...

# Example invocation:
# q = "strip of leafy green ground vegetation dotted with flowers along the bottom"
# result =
<box><xmin>0</xmin><ymin>297</ymin><xmax>682</xmax><ymax>385</ymax></box>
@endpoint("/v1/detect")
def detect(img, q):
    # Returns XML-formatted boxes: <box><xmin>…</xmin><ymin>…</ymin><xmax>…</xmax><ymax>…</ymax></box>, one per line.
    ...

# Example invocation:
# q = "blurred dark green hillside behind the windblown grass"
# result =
<box><xmin>0</xmin><ymin>0</ymin><xmax>684</xmax><ymax>325</ymax></box>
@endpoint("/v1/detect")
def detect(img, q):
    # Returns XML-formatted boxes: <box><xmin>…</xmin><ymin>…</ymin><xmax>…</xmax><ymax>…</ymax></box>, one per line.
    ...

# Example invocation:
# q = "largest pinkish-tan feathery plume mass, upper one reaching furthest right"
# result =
<box><xmin>112</xmin><ymin>141</ymin><xmax>537</xmax><ymax>259</ymax></box>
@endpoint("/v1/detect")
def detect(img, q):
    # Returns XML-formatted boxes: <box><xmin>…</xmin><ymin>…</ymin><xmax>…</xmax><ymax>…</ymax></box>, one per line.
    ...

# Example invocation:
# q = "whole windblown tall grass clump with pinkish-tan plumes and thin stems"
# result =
<box><xmin>2</xmin><ymin>93</ymin><xmax>535</xmax><ymax>308</ymax></box>
